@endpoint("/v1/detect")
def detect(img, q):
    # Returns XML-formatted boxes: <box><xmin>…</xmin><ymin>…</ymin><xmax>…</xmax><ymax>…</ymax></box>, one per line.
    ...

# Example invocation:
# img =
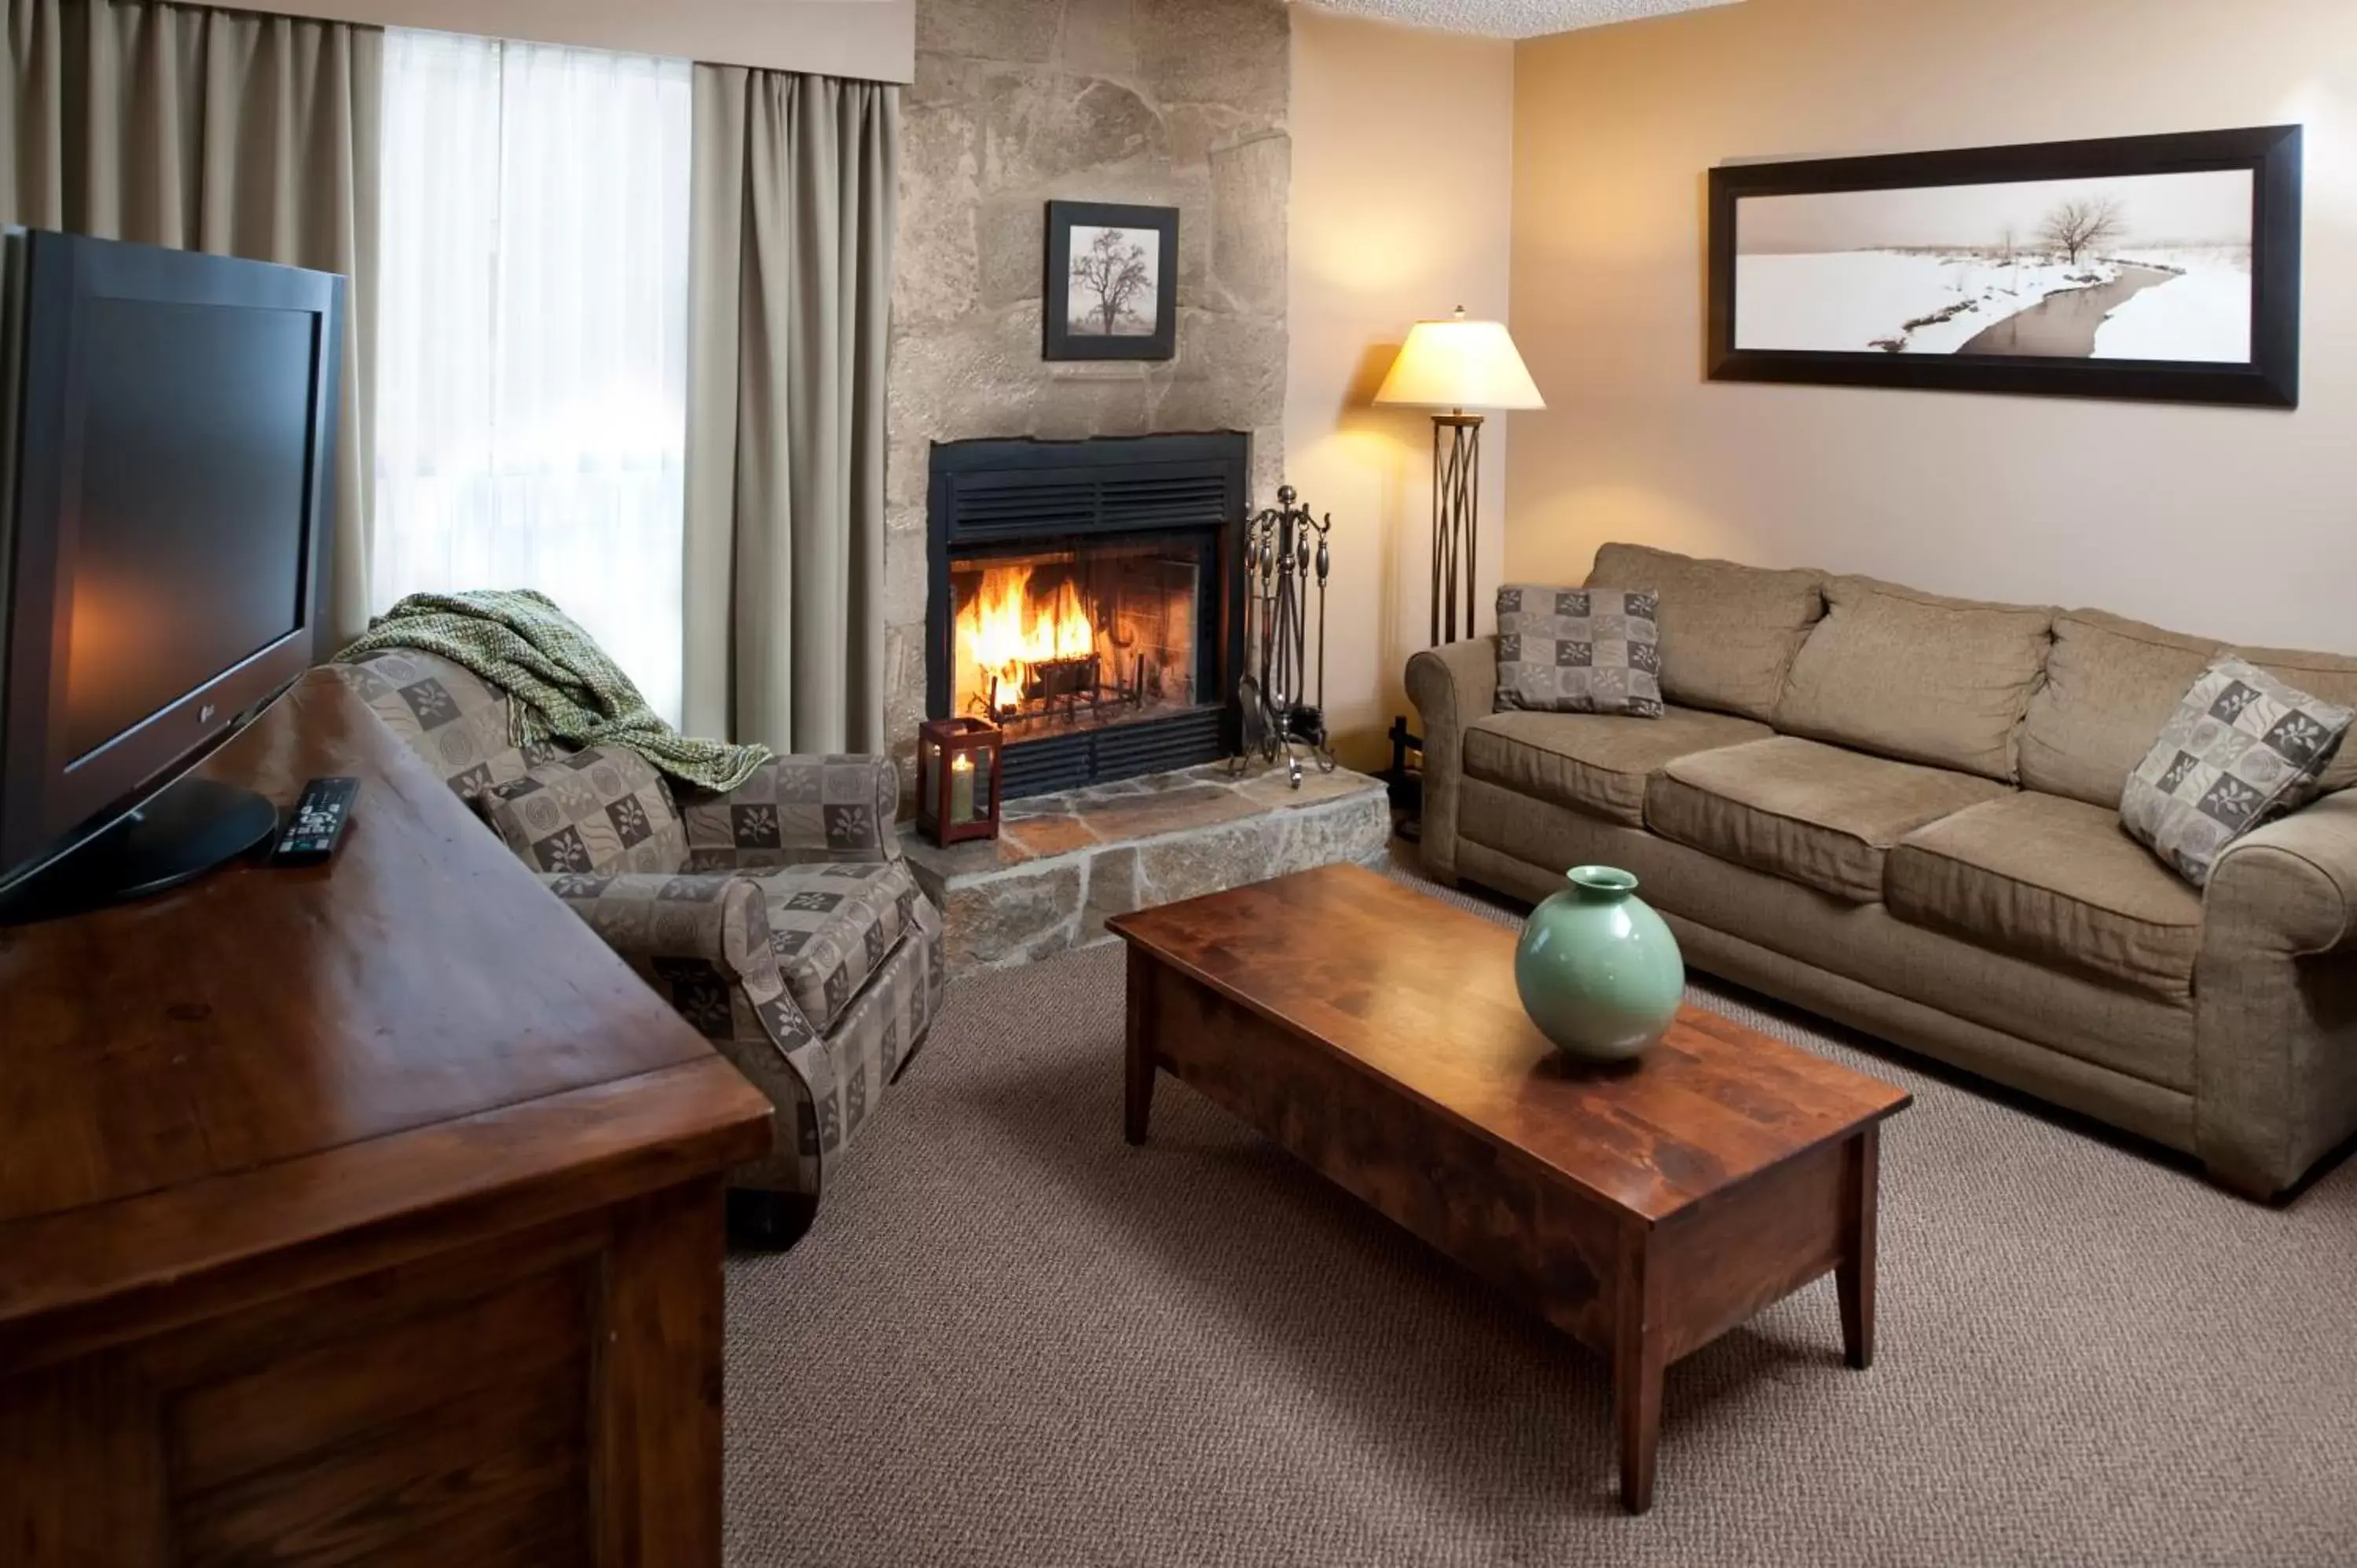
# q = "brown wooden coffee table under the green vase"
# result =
<box><xmin>1108</xmin><ymin>866</ymin><xmax>1909</xmax><ymax>1514</ymax></box>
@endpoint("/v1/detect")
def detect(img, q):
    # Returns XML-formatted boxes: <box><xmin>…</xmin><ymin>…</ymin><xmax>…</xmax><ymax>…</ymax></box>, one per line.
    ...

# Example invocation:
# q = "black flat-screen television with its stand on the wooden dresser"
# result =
<box><xmin>0</xmin><ymin>229</ymin><xmax>344</xmax><ymax>920</ymax></box>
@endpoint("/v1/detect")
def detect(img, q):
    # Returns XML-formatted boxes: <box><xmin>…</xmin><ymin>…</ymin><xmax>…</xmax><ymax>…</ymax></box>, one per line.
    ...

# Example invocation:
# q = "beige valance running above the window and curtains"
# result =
<box><xmin>262</xmin><ymin>0</ymin><xmax>917</xmax><ymax>82</ymax></box>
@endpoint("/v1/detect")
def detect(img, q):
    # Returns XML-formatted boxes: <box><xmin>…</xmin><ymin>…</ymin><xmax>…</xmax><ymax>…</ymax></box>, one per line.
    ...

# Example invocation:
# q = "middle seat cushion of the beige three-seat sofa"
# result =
<box><xmin>1645</xmin><ymin>735</ymin><xmax>2008</xmax><ymax>903</ymax></box>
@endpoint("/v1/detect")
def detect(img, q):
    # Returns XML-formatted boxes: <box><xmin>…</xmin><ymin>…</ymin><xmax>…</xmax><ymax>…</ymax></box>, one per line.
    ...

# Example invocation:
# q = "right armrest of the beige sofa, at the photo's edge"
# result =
<box><xmin>2194</xmin><ymin>790</ymin><xmax>2357</xmax><ymax>1198</ymax></box>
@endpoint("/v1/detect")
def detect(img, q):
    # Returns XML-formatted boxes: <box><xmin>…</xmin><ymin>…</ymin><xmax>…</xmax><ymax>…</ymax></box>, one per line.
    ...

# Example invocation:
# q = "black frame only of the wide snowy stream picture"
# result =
<box><xmin>1706</xmin><ymin>125</ymin><xmax>2300</xmax><ymax>408</ymax></box>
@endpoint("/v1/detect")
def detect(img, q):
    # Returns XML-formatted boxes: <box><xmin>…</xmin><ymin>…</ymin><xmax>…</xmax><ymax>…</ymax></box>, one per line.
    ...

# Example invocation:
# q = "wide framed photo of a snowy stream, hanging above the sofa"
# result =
<box><xmin>1709</xmin><ymin>125</ymin><xmax>2300</xmax><ymax>408</ymax></box>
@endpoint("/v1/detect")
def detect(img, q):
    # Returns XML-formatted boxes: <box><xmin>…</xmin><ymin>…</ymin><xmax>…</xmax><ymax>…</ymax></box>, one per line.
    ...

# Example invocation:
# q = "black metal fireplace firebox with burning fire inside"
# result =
<box><xmin>926</xmin><ymin>431</ymin><xmax>1252</xmax><ymax>797</ymax></box>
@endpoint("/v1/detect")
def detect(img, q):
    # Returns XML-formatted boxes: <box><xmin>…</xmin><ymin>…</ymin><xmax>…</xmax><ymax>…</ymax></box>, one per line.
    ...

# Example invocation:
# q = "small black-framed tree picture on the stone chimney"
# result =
<box><xmin>1039</xmin><ymin>200</ymin><xmax>1178</xmax><ymax>358</ymax></box>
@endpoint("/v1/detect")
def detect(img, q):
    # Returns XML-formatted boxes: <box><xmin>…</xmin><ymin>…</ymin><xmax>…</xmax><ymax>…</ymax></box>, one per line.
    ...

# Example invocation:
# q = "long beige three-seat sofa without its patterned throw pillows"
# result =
<box><xmin>1407</xmin><ymin>544</ymin><xmax>2357</xmax><ymax>1196</ymax></box>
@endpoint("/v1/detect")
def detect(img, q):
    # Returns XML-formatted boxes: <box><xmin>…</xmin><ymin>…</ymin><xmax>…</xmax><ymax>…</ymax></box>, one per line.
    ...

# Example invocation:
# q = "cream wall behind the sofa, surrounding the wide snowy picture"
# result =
<box><xmin>1506</xmin><ymin>0</ymin><xmax>2357</xmax><ymax>650</ymax></box>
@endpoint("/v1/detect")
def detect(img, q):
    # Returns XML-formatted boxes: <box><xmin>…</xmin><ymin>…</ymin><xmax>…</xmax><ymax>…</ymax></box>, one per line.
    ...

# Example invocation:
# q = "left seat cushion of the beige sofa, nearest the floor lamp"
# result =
<box><xmin>1464</xmin><ymin>707</ymin><xmax>1770</xmax><ymax>828</ymax></box>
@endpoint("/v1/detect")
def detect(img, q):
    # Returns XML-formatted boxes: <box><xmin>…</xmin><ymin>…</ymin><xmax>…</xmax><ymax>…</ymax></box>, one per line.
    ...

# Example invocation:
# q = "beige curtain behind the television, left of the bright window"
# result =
<box><xmin>0</xmin><ymin>0</ymin><xmax>384</xmax><ymax>655</ymax></box>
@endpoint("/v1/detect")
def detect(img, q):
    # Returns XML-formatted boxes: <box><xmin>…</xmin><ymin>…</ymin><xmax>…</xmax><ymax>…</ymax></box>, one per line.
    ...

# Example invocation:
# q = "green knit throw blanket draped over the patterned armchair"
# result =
<box><xmin>335</xmin><ymin>589</ymin><xmax>771</xmax><ymax>793</ymax></box>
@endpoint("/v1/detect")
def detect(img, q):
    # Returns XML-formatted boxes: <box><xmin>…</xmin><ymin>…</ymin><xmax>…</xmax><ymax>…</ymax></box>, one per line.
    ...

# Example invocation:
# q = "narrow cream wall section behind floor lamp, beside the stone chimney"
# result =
<box><xmin>1256</xmin><ymin>5</ymin><xmax>1518</xmax><ymax>766</ymax></box>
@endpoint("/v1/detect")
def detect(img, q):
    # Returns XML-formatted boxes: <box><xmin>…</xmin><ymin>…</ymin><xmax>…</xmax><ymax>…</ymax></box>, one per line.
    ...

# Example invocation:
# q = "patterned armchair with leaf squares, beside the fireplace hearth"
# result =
<box><xmin>339</xmin><ymin>648</ymin><xmax>948</xmax><ymax>1243</ymax></box>
